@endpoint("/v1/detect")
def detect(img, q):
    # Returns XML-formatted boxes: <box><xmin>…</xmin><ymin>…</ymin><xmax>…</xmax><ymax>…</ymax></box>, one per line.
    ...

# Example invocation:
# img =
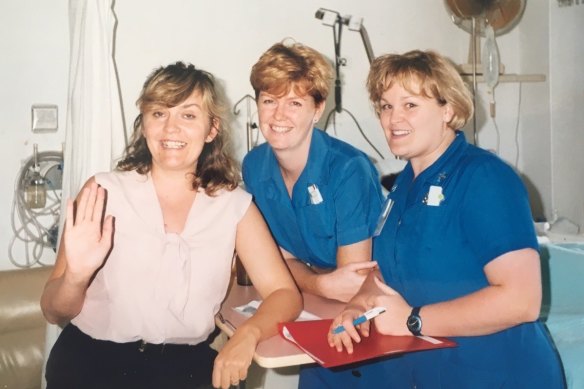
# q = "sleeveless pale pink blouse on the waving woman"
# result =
<box><xmin>72</xmin><ymin>171</ymin><xmax>251</xmax><ymax>344</ymax></box>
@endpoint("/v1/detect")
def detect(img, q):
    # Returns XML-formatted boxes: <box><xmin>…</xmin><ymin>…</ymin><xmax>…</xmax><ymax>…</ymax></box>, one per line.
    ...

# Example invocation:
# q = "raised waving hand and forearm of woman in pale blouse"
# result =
<box><xmin>41</xmin><ymin>178</ymin><xmax>113</xmax><ymax>324</ymax></box>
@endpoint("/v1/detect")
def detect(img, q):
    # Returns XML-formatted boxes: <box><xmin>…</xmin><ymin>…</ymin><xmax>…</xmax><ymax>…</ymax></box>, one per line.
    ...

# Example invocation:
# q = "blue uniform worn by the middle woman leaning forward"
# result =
<box><xmin>242</xmin><ymin>129</ymin><xmax>383</xmax><ymax>389</ymax></box>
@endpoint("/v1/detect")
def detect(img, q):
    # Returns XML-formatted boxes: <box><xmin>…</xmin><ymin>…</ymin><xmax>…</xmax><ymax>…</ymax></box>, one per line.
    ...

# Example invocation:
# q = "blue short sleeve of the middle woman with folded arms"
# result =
<box><xmin>335</xmin><ymin>157</ymin><xmax>382</xmax><ymax>246</ymax></box>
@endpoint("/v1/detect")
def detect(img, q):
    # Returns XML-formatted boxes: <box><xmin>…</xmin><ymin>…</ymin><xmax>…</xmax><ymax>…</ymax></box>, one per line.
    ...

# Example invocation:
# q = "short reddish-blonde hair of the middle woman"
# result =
<box><xmin>250</xmin><ymin>43</ymin><xmax>333</xmax><ymax>105</ymax></box>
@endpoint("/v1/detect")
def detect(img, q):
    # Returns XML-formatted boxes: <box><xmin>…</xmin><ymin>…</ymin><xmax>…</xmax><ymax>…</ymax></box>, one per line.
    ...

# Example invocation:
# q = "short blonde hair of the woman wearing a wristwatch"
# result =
<box><xmin>367</xmin><ymin>50</ymin><xmax>474</xmax><ymax>129</ymax></box>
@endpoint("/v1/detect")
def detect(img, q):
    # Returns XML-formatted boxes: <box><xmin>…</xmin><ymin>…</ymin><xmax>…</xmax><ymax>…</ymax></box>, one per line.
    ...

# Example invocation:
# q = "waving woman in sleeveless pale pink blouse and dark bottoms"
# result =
<box><xmin>41</xmin><ymin>62</ymin><xmax>302</xmax><ymax>389</ymax></box>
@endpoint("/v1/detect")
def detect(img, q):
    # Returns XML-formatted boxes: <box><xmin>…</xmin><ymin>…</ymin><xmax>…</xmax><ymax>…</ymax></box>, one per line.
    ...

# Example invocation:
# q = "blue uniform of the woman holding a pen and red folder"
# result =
<box><xmin>373</xmin><ymin>131</ymin><xmax>564</xmax><ymax>389</ymax></box>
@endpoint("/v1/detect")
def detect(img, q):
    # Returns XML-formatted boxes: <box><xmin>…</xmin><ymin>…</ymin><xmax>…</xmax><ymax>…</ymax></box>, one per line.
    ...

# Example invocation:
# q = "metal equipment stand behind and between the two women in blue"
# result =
<box><xmin>314</xmin><ymin>8</ymin><xmax>384</xmax><ymax>159</ymax></box>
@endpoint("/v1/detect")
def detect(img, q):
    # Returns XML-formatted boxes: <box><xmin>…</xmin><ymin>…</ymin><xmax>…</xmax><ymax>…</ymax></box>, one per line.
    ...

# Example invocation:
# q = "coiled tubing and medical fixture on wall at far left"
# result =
<box><xmin>8</xmin><ymin>144</ymin><xmax>63</xmax><ymax>268</ymax></box>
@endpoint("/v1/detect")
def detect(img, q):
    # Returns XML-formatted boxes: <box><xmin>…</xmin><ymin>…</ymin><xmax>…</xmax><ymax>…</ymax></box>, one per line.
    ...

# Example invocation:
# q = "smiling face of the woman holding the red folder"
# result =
<box><xmin>379</xmin><ymin>82</ymin><xmax>455</xmax><ymax>175</ymax></box>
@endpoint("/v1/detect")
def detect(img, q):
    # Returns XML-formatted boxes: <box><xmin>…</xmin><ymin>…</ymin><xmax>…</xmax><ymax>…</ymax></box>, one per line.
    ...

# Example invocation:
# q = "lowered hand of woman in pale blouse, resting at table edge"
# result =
<box><xmin>213</xmin><ymin>327</ymin><xmax>258</xmax><ymax>389</ymax></box>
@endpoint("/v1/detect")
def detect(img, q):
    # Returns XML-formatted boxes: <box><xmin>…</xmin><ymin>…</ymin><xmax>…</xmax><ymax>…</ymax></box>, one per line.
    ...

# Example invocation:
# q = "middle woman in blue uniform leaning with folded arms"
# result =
<box><xmin>243</xmin><ymin>43</ymin><xmax>382</xmax><ymax>388</ymax></box>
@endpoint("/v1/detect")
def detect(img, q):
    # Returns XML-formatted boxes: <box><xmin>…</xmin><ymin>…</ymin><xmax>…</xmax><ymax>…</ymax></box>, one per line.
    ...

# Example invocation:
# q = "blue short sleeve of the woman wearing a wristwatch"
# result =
<box><xmin>461</xmin><ymin>159</ymin><xmax>538</xmax><ymax>265</ymax></box>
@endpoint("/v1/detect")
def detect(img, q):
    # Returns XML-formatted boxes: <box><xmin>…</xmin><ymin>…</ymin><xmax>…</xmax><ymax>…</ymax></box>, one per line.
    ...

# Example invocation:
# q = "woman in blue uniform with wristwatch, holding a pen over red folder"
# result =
<box><xmin>329</xmin><ymin>51</ymin><xmax>564</xmax><ymax>389</ymax></box>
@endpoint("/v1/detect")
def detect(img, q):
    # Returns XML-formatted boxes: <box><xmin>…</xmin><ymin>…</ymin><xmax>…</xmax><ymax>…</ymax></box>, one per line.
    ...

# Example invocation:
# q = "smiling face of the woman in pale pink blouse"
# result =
<box><xmin>142</xmin><ymin>91</ymin><xmax>217</xmax><ymax>173</ymax></box>
